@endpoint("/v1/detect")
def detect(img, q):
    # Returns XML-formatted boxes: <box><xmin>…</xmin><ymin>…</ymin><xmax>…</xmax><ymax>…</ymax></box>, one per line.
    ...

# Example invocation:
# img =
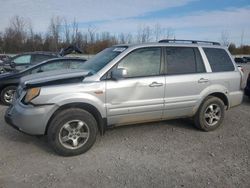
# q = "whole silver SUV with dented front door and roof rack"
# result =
<box><xmin>5</xmin><ymin>40</ymin><xmax>243</xmax><ymax>156</ymax></box>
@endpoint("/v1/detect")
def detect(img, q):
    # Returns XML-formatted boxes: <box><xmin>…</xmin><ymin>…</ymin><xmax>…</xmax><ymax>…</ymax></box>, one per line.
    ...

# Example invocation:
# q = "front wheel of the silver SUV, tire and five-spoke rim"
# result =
<box><xmin>48</xmin><ymin>108</ymin><xmax>98</xmax><ymax>156</ymax></box>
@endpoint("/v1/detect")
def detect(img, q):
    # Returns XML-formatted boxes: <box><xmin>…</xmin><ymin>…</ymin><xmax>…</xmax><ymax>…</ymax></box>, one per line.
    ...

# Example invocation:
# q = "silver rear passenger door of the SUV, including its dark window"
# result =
<box><xmin>163</xmin><ymin>47</ymin><xmax>210</xmax><ymax>119</ymax></box>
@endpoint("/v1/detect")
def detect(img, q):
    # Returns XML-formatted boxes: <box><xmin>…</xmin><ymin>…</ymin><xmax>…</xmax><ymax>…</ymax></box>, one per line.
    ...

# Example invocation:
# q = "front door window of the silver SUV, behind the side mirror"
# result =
<box><xmin>118</xmin><ymin>48</ymin><xmax>161</xmax><ymax>77</ymax></box>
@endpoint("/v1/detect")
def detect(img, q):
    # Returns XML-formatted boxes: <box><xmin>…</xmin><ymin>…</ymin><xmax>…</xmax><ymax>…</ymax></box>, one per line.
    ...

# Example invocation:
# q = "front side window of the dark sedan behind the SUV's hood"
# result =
<box><xmin>32</xmin><ymin>61</ymin><xmax>67</xmax><ymax>74</ymax></box>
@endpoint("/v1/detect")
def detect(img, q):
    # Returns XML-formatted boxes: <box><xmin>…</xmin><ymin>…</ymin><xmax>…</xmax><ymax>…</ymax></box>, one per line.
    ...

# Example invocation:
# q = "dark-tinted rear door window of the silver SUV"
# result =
<box><xmin>166</xmin><ymin>47</ymin><xmax>205</xmax><ymax>75</ymax></box>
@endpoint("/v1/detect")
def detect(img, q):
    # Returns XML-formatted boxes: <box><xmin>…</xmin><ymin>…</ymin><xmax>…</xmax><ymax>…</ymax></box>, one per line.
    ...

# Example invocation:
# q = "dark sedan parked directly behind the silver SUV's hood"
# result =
<box><xmin>0</xmin><ymin>57</ymin><xmax>86</xmax><ymax>105</ymax></box>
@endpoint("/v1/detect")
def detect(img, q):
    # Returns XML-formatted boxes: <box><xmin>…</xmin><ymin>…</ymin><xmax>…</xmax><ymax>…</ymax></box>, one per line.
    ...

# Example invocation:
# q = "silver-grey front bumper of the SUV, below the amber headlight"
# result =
<box><xmin>5</xmin><ymin>103</ymin><xmax>56</xmax><ymax>135</ymax></box>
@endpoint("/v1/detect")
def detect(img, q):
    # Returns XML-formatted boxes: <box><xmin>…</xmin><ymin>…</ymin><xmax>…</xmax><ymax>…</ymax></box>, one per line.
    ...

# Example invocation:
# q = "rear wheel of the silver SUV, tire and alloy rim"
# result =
<box><xmin>194</xmin><ymin>96</ymin><xmax>225</xmax><ymax>132</ymax></box>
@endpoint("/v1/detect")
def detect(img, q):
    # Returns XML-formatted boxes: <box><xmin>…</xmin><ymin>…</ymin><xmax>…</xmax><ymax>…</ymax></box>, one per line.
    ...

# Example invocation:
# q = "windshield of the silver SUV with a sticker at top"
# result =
<box><xmin>81</xmin><ymin>46</ymin><xmax>127</xmax><ymax>73</ymax></box>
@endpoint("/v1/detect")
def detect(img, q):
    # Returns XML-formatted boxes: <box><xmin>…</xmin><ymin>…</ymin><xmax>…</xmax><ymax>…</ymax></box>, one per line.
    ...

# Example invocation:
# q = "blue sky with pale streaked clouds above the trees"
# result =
<box><xmin>0</xmin><ymin>0</ymin><xmax>250</xmax><ymax>44</ymax></box>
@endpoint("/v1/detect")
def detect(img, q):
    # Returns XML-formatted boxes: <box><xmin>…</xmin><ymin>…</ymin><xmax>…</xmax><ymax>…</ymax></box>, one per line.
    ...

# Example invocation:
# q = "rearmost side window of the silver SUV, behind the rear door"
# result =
<box><xmin>203</xmin><ymin>48</ymin><xmax>234</xmax><ymax>72</ymax></box>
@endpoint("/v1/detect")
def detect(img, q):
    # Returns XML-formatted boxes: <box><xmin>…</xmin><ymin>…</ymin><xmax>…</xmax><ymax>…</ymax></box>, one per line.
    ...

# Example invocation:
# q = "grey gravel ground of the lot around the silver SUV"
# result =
<box><xmin>0</xmin><ymin>63</ymin><xmax>250</xmax><ymax>188</ymax></box>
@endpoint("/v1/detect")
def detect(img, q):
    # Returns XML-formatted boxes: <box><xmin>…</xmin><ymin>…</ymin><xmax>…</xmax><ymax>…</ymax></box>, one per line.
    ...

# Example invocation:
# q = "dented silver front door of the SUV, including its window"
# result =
<box><xmin>106</xmin><ymin>47</ymin><xmax>165</xmax><ymax>125</ymax></box>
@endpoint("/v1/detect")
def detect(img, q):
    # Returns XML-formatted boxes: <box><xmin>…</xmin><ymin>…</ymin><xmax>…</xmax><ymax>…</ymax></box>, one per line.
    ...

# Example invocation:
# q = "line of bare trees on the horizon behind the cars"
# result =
<box><xmin>0</xmin><ymin>16</ymin><xmax>250</xmax><ymax>54</ymax></box>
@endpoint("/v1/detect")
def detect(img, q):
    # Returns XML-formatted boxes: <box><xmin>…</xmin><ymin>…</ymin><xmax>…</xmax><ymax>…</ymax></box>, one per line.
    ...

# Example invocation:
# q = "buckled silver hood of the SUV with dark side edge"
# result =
<box><xmin>20</xmin><ymin>69</ymin><xmax>90</xmax><ymax>88</ymax></box>
